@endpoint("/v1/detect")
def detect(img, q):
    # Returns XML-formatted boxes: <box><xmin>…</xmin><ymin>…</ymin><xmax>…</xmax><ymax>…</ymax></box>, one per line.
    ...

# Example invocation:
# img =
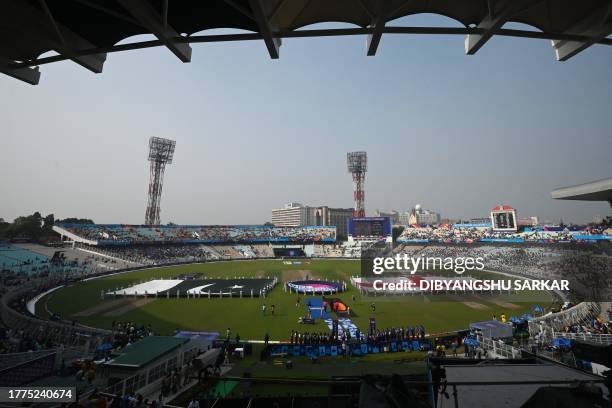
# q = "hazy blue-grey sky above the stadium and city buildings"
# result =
<box><xmin>0</xmin><ymin>17</ymin><xmax>612</xmax><ymax>224</ymax></box>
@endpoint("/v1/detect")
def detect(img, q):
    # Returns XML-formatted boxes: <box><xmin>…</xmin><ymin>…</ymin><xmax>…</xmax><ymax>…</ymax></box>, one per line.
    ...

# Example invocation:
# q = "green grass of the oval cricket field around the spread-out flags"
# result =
<box><xmin>36</xmin><ymin>260</ymin><xmax>553</xmax><ymax>340</ymax></box>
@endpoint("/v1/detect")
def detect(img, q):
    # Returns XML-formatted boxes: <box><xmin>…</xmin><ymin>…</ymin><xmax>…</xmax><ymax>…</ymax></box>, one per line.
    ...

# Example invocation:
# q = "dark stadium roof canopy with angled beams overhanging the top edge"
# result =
<box><xmin>0</xmin><ymin>0</ymin><xmax>612</xmax><ymax>84</ymax></box>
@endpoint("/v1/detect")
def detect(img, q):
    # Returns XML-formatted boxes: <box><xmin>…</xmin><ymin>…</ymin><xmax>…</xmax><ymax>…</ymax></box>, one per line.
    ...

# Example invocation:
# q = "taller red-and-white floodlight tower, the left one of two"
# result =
<box><xmin>145</xmin><ymin>137</ymin><xmax>176</xmax><ymax>225</ymax></box>
